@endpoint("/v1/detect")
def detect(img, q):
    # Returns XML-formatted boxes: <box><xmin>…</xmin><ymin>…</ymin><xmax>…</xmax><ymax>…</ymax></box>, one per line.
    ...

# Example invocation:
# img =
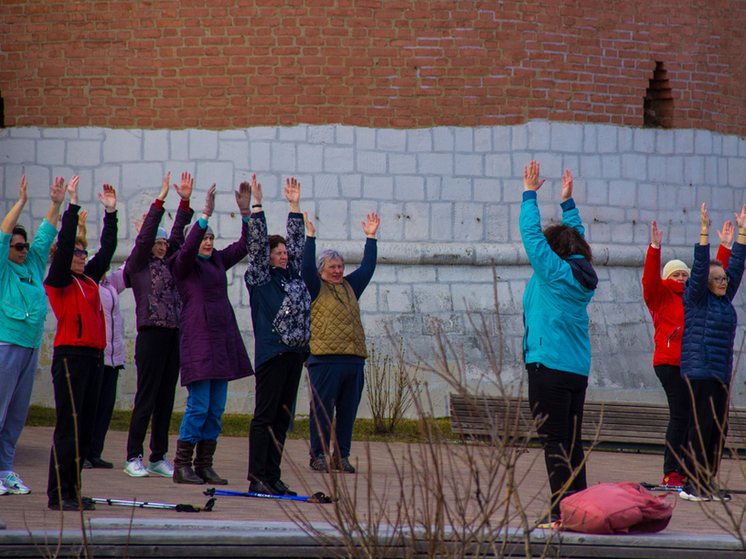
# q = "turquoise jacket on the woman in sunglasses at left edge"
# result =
<box><xmin>0</xmin><ymin>219</ymin><xmax>57</xmax><ymax>348</ymax></box>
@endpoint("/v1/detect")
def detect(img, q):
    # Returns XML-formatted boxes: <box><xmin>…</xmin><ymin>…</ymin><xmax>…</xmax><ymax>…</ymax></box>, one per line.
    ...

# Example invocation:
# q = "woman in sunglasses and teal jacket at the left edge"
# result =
<box><xmin>0</xmin><ymin>175</ymin><xmax>65</xmax><ymax>495</ymax></box>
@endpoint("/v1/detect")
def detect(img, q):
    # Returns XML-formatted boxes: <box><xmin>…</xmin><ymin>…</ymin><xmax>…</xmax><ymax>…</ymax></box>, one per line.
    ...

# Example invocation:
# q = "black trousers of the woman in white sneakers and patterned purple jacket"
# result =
<box><xmin>127</xmin><ymin>328</ymin><xmax>180</xmax><ymax>462</ymax></box>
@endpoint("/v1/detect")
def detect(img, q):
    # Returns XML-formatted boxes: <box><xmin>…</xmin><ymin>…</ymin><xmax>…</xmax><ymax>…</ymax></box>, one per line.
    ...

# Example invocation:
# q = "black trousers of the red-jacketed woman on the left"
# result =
<box><xmin>47</xmin><ymin>352</ymin><xmax>104</xmax><ymax>505</ymax></box>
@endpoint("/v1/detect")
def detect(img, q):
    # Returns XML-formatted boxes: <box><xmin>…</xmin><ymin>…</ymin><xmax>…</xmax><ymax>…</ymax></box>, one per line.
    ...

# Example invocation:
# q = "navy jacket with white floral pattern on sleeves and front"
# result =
<box><xmin>244</xmin><ymin>212</ymin><xmax>311</xmax><ymax>367</ymax></box>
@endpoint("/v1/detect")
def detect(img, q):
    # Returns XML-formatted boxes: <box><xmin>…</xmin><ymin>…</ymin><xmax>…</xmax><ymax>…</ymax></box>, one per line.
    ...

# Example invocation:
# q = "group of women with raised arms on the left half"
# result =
<box><xmin>0</xmin><ymin>173</ymin><xmax>380</xmax><ymax>510</ymax></box>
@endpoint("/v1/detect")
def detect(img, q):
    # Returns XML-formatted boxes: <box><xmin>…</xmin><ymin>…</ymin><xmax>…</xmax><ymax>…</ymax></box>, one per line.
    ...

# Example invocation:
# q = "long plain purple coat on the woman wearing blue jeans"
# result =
<box><xmin>169</xmin><ymin>219</ymin><xmax>254</xmax><ymax>386</ymax></box>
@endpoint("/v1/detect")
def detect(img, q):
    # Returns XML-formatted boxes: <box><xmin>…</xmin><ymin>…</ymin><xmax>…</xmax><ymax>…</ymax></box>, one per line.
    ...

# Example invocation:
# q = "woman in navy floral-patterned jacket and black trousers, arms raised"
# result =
<box><xmin>244</xmin><ymin>175</ymin><xmax>311</xmax><ymax>496</ymax></box>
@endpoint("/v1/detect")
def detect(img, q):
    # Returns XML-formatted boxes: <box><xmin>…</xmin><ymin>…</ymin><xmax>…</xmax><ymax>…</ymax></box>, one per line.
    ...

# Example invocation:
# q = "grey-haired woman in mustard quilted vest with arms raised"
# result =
<box><xmin>301</xmin><ymin>213</ymin><xmax>381</xmax><ymax>474</ymax></box>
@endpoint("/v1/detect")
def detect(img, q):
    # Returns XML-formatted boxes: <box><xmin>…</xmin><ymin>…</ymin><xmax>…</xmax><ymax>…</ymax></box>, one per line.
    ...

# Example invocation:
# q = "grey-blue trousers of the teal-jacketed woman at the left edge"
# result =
<box><xmin>0</xmin><ymin>345</ymin><xmax>39</xmax><ymax>471</ymax></box>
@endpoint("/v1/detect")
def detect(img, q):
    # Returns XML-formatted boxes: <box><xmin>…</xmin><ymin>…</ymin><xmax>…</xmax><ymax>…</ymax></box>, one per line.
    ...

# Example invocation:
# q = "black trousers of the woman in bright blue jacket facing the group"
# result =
<box><xmin>526</xmin><ymin>363</ymin><xmax>588</xmax><ymax>514</ymax></box>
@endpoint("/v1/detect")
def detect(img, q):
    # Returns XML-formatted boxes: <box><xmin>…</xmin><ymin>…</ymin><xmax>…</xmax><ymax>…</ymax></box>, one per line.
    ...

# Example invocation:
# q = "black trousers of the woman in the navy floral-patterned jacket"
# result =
<box><xmin>248</xmin><ymin>352</ymin><xmax>306</xmax><ymax>483</ymax></box>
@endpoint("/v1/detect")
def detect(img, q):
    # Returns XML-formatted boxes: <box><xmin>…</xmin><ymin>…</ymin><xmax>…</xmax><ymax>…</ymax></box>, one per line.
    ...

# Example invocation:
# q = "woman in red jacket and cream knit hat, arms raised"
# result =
<box><xmin>642</xmin><ymin>221</ymin><xmax>733</xmax><ymax>487</ymax></box>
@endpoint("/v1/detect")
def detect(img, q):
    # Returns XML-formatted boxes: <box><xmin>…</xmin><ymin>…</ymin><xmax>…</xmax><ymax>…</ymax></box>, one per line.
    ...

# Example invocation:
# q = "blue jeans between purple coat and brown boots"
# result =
<box><xmin>179</xmin><ymin>380</ymin><xmax>228</xmax><ymax>443</ymax></box>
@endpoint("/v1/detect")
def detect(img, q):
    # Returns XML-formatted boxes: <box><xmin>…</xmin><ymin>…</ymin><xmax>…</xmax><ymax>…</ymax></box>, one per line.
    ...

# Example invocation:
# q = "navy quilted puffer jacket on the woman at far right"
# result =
<box><xmin>681</xmin><ymin>243</ymin><xmax>746</xmax><ymax>383</ymax></box>
